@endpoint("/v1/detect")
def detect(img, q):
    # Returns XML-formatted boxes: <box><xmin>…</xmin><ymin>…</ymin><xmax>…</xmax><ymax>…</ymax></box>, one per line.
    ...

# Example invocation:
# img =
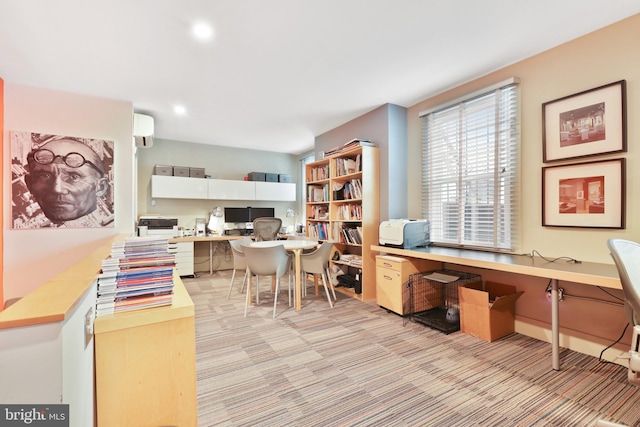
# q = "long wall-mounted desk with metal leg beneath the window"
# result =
<box><xmin>371</xmin><ymin>245</ymin><xmax>622</xmax><ymax>370</ymax></box>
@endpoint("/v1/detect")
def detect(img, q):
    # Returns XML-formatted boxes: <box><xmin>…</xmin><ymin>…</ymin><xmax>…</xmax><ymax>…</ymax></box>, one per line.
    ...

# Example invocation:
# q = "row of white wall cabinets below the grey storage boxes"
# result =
<box><xmin>151</xmin><ymin>175</ymin><xmax>296</xmax><ymax>202</ymax></box>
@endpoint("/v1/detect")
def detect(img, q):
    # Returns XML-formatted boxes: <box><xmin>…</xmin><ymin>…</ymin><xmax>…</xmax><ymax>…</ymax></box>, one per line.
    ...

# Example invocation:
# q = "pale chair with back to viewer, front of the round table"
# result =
<box><xmin>242</xmin><ymin>245</ymin><xmax>291</xmax><ymax>319</ymax></box>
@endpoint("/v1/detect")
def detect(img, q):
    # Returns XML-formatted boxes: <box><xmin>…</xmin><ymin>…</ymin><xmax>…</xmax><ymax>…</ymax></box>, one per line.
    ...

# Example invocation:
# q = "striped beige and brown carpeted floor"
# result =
<box><xmin>183</xmin><ymin>271</ymin><xmax>640</xmax><ymax>427</ymax></box>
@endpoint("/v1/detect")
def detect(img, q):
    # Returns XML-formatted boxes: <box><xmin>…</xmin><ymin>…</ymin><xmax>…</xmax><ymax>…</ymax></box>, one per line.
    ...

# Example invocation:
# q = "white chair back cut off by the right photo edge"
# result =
<box><xmin>607</xmin><ymin>239</ymin><xmax>640</xmax><ymax>326</ymax></box>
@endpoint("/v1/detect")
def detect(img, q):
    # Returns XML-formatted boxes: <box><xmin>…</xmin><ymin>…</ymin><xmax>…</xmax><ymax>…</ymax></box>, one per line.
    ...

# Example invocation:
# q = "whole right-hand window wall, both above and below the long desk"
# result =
<box><xmin>408</xmin><ymin>15</ymin><xmax>640</xmax><ymax>355</ymax></box>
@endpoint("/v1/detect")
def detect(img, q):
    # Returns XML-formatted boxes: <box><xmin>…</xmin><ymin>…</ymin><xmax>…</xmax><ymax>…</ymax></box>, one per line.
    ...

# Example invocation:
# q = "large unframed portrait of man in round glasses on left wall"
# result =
<box><xmin>10</xmin><ymin>131</ymin><xmax>114</xmax><ymax>229</ymax></box>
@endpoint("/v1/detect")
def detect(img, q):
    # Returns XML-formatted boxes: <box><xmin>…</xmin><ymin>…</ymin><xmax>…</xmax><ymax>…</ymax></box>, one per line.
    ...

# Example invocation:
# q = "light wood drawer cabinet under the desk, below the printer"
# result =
<box><xmin>376</xmin><ymin>255</ymin><xmax>440</xmax><ymax>315</ymax></box>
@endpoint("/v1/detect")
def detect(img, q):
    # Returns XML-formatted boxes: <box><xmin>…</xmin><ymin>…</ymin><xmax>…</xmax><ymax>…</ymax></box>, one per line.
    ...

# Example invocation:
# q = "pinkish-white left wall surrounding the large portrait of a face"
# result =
<box><xmin>3</xmin><ymin>81</ymin><xmax>135</xmax><ymax>300</ymax></box>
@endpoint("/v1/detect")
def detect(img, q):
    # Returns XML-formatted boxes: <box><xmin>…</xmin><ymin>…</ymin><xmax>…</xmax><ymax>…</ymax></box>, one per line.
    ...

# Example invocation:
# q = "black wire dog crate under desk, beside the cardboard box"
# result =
<box><xmin>405</xmin><ymin>270</ymin><xmax>482</xmax><ymax>334</ymax></box>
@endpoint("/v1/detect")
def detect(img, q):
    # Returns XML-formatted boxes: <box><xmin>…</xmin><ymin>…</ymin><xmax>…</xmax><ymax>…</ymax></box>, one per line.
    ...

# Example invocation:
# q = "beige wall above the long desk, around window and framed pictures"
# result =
<box><xmin>408</xmin><ymin>15</ymin><xmax>640</xmax><ymax>263</ymax></box>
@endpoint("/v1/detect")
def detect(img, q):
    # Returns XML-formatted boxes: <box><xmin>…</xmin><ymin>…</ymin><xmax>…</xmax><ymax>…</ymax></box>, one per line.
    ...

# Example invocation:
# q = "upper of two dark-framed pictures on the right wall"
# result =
<box><xmin>542</xmin><ymin>80</ymin><xmax>627</xmax><ymax>163</ymax></box>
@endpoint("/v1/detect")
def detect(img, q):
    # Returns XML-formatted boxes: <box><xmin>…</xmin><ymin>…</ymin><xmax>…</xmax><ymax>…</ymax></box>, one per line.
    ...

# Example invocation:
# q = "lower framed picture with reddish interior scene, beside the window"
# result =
<box><xmin>542</xmin><ymin>159</ymin><xmax>625</xmax><ymax>228</ymax></box>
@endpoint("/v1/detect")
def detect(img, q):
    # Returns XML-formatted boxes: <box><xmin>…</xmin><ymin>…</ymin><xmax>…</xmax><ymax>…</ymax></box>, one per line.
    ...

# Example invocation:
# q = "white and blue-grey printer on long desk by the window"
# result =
<box><xmin>379</xmin><ymin>219</ymin><xmax>431</xmax><ymax>249</ymax></box>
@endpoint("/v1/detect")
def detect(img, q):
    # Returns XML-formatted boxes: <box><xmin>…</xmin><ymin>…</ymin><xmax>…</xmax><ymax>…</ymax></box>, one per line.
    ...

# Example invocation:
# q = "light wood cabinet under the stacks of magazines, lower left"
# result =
<box><xmin>94</xmin><ymin>278</ymin><xmax>198</xmax><ymax>427</ymax></box>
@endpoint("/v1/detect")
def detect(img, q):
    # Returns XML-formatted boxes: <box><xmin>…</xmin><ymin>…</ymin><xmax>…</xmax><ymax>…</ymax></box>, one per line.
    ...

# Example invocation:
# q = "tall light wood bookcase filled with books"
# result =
<box><xmin>305</xmin><ymin>146</ymin><xmax>380</xmax><ymax>301</ymax></box>
